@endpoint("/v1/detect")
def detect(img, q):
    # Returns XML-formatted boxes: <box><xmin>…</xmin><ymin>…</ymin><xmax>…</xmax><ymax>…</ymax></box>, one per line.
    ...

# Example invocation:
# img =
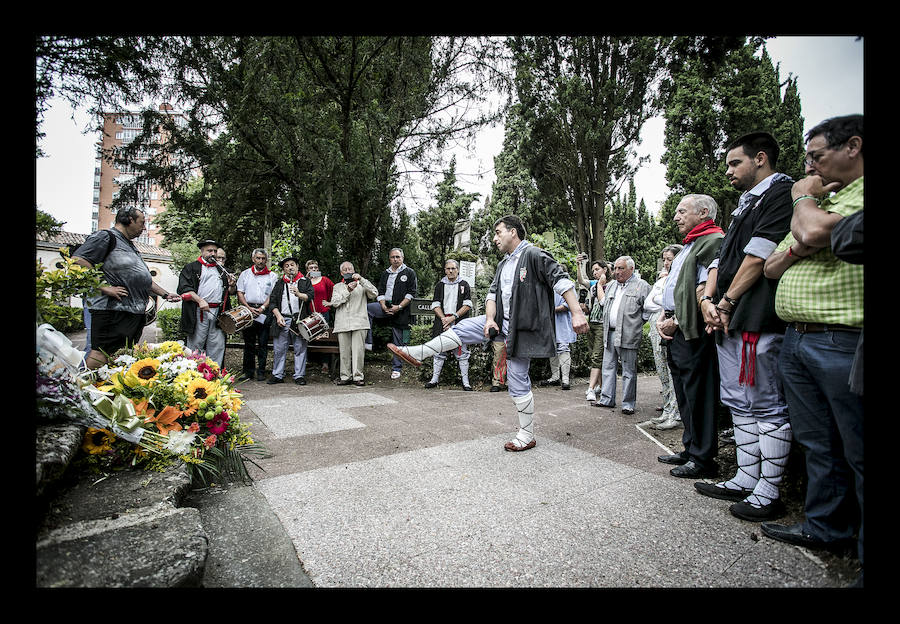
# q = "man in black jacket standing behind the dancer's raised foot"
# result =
<box><xmin>366</xmin><ymin>247</ymin><xmax>418</xmax><ymax>379</ymax></box>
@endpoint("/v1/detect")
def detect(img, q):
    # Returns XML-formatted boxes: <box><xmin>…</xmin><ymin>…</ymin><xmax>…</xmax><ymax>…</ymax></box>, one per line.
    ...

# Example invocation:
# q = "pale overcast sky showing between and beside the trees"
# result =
<box><xmin>35</xmin><ymin>37</ymin><xmax>864</xmax><ymax>234</ymax></box>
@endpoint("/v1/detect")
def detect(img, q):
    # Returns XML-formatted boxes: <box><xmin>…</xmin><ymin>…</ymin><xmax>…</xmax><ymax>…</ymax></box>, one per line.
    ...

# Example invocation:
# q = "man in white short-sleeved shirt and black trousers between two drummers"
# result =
<box><xmin>237</xmin><ymin>248</ymin><xmax>278</xmax><ymax>381</ymax></box>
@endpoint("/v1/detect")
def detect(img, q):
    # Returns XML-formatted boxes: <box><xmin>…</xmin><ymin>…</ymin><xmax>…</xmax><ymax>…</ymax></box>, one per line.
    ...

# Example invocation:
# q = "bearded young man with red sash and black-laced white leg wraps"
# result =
<box><xmin>694</xmin><ymin>132</ymin><xmax>794</xmax><ymax>522</ymax></box>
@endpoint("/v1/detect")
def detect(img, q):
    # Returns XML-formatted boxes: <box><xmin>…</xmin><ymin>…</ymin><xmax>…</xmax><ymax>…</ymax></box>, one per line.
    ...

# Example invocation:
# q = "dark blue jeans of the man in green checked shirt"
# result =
<box><xmin>778</xmin><ymin>327</ymin><xmax>863</xmax><ymax>563</ymax></box>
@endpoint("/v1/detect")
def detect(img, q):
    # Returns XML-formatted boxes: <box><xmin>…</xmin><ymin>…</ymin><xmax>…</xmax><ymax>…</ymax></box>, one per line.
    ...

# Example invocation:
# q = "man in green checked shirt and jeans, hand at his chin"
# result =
<box><xmin>761</xmin><ymin>115</ymin><xmax>864</xmax><ymax>584</ymax></box>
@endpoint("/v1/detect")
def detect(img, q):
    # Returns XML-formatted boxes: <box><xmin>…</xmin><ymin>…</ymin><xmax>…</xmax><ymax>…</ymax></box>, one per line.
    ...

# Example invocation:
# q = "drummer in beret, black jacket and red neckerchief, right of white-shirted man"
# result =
<box><xmin>266</xmin><ymin>257</ymin><xmax>315</xmax><ymax>386</ymax></box>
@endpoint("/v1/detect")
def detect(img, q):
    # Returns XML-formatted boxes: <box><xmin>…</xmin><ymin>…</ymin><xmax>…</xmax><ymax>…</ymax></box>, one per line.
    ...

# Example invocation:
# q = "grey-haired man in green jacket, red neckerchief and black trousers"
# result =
<box><xmin>656</xmin><ymin>195</ymin><xmax>724</xmax><ymax>479</ymax></box>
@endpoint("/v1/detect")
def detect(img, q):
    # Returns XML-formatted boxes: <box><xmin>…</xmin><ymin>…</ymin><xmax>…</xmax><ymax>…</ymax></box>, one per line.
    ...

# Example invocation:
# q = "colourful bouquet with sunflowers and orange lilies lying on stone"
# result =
<box><xmin>38</xmin><ymin>332</ymin><xmax>265</xmax><ymax>483</ymax></box>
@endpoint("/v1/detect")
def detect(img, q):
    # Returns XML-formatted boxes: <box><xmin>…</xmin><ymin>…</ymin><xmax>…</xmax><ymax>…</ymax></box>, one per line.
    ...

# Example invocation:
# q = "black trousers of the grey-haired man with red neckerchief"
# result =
<box><xmin>667</xmin><ymin>328</ymin><xmax>719</xmax><ymax>468</ymax></box>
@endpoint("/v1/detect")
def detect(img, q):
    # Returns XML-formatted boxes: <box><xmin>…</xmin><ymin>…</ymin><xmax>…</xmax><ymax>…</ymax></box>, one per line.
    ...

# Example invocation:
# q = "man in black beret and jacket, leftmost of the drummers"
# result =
<box><xmin>178</xmin><ymin>239</ymin><xmax>234</xmax><ymax>367</ymax></box>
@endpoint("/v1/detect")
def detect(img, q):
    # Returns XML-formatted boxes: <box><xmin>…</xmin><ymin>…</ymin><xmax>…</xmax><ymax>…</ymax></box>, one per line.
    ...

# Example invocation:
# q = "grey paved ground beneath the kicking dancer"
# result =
<box><xmin>194</xmin><ymin>371</ymin><xmax>847</xmax><ymax>588</ymax></box>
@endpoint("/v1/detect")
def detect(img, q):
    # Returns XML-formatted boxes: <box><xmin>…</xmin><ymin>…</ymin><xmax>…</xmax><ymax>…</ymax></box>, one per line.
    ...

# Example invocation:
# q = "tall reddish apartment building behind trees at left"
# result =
<box><xmin>91</xmin><ymin>104</ymin><xmax>187</xmax><ymax>247</ymax></box>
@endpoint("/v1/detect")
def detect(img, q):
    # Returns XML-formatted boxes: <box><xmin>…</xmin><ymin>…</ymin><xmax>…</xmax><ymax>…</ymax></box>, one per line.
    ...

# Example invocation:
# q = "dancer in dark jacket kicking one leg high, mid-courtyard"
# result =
<box><xmin>388</xmin><ymin>215</ymin><xmax>588</xmax><ymax>451</ymax></box>
